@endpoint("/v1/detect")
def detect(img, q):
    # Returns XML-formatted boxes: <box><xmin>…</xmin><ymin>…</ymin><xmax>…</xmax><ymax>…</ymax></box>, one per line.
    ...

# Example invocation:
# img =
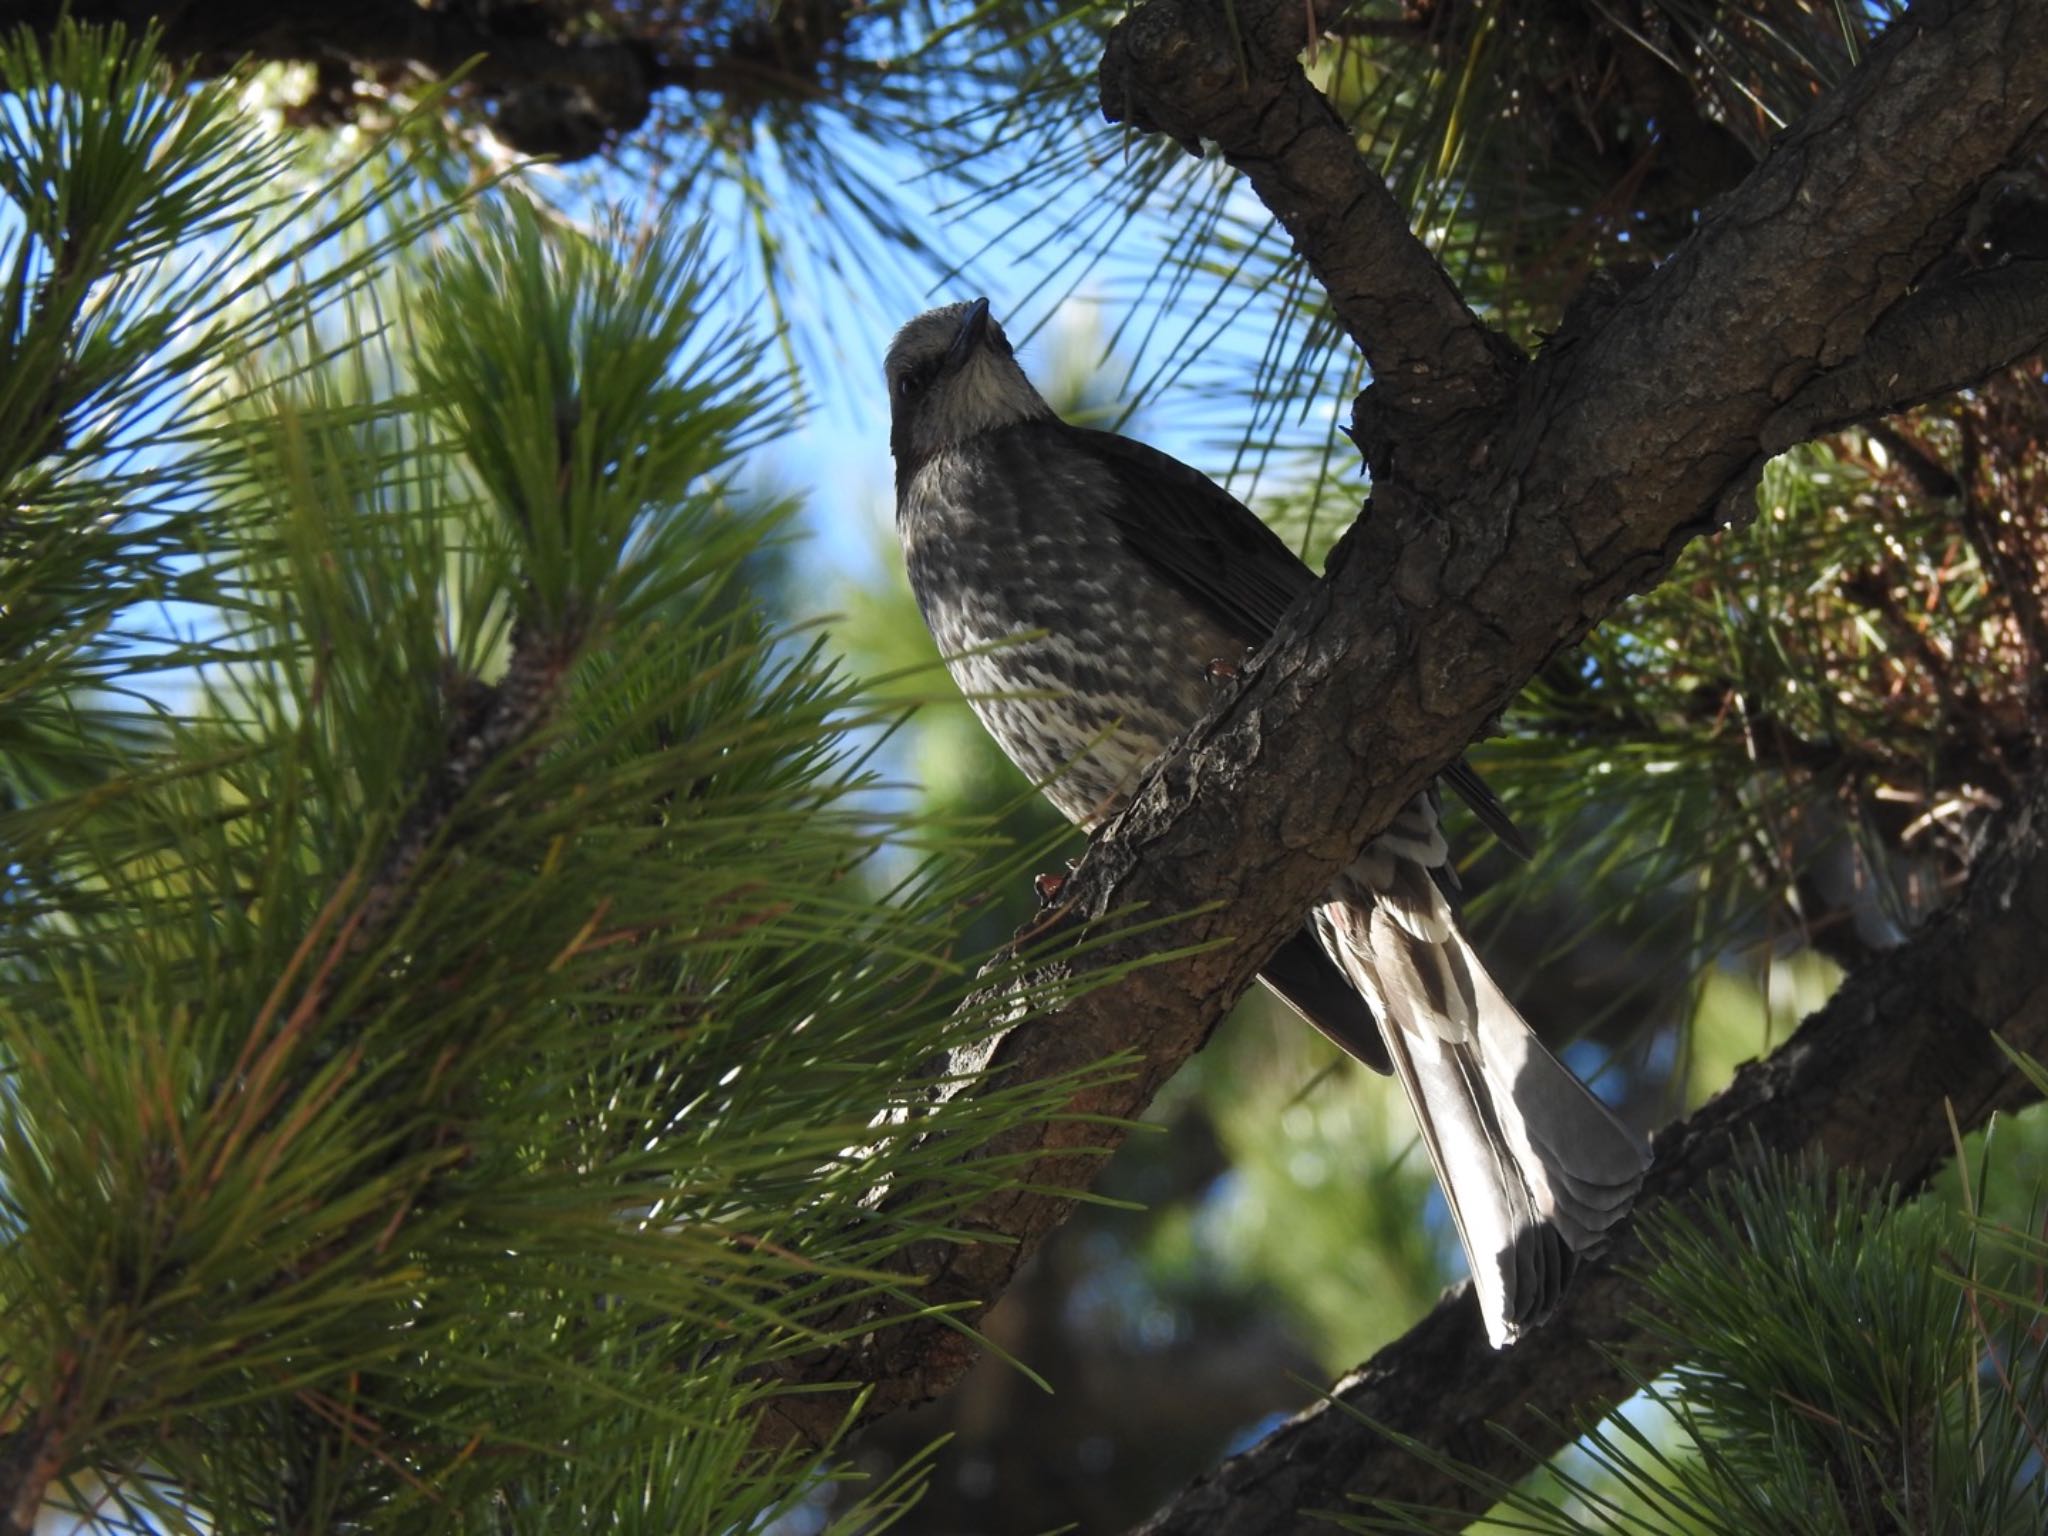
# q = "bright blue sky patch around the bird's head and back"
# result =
<box><xmin>667</xmin><ymin>115</ymin><xmax>1354</xmax><ymax>610</ymax></box>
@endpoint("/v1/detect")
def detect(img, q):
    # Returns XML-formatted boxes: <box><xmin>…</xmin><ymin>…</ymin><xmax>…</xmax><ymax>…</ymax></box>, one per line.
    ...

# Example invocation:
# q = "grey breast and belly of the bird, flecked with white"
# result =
<box><xmin>897</xmin><ymin>430</ymin><xmax>1243</xmax><ymax>825</ymax></box>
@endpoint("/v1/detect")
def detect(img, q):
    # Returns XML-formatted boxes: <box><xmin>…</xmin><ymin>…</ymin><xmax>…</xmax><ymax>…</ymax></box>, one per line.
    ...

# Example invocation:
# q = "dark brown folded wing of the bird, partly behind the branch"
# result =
<box><xmin>1042</xmin><ymin>422</ymin><xmax>1530</xmax><ymax>858</ymax></box>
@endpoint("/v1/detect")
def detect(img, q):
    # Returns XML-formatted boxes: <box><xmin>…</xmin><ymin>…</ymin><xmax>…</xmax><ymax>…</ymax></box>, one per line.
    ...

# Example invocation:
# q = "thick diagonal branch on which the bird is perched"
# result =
<box><xmin>762</xmin><ymin>0</ymin><xmax>2048</xmax><ymax>1466</ymax></box>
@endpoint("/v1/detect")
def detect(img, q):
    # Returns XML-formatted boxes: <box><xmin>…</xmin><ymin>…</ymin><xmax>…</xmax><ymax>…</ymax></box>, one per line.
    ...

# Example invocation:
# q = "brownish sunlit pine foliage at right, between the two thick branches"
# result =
<box><xmin>1449</xmin><ymin>367</ymin><xmax>2048</xmax><ymax>1073</ymax></box>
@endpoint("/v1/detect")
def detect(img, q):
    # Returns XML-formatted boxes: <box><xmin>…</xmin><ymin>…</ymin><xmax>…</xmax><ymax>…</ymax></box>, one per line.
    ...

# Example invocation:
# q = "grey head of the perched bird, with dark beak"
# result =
<box><xmin>883</xmin><ymin>299</ymin><xmax>1053</xmax><ymax>473</ymax></box>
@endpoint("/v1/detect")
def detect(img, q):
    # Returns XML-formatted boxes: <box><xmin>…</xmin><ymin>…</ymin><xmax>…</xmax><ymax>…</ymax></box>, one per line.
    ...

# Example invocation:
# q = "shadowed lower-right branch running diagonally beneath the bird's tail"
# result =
<box><xmin>1141</xmin><ymin>778</ymin><xmax>2048</xmax><ymax>1536</ymax></box>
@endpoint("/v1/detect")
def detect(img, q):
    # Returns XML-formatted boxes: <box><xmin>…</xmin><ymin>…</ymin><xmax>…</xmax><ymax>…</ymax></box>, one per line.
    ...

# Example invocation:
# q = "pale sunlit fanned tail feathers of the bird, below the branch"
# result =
<box><xmin>1319</xmin><ymin>883</ymin><xmax>1649</xmax><ymax>1348</ymax></box>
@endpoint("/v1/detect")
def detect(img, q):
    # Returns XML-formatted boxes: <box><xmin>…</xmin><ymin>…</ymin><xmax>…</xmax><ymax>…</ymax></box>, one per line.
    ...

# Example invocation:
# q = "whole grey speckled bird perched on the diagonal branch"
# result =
<box><xmin>883</xmin><ymin>299</ymin><xmax>1649</xmax><ymax>1350</ymax></box>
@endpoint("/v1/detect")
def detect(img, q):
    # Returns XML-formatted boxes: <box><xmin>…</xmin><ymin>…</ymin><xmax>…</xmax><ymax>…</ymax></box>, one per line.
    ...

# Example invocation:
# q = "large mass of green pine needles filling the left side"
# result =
<box><xmin>0</xmin><ymin>29</ymin><xmax>1138</xmax><ymax>1534</ymax></box>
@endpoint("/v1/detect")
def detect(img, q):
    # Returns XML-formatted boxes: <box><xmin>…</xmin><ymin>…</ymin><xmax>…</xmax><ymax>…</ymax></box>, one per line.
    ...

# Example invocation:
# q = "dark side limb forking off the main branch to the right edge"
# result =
<box><xmin>1763</xmin><ymin>262</ymin><xmax>2048</xmax><ymax>451</ymax></box>
